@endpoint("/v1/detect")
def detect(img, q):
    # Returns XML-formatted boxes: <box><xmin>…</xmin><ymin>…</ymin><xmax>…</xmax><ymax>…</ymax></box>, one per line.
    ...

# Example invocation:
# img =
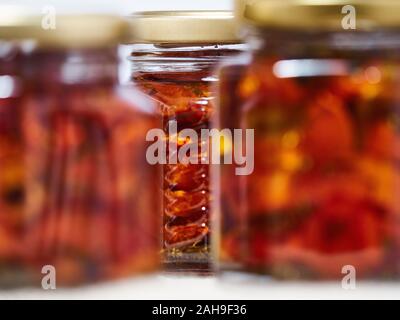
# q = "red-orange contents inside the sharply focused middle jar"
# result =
<box><xmin>134</xmin><ymin>65</ymin><xmax>213</xmax><ymax>264</ymax></box>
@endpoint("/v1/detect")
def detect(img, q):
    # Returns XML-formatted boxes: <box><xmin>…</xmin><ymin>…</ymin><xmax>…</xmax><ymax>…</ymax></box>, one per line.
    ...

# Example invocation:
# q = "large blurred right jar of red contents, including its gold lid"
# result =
<box><xmin>217</xmin><ymin>0</ymin><xmax>400</xmax><ymax>279</ymax></box>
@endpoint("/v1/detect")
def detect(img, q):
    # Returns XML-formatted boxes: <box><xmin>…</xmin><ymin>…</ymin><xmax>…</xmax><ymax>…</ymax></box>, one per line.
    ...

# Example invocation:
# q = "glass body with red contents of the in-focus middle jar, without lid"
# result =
<box><xmin>132</xmin><ymin>46</ymin><xmax>242</xmax><ymax>270</ymax></box>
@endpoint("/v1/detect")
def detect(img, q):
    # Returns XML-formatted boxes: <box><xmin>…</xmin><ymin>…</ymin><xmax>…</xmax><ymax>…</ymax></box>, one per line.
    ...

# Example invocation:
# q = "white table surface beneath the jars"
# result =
<box><xmin>0</xmin><ymin>274</ymin><xmax>400</xmax><ymax>300</ymax></box>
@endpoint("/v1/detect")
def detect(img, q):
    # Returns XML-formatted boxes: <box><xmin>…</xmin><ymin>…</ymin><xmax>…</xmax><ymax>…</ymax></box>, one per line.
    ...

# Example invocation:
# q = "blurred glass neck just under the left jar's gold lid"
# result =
<box><xmin>24</xmin><ymin>49</ymin><xmax>118</xmax><ymax>85</ymax></box>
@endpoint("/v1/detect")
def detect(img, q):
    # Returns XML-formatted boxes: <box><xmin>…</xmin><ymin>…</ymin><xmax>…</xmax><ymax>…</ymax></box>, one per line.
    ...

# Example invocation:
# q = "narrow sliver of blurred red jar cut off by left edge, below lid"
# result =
<box><xmin>0</xmin><ymin>40</ymin><xmax>25</xmax><ymax>284</ymax></box>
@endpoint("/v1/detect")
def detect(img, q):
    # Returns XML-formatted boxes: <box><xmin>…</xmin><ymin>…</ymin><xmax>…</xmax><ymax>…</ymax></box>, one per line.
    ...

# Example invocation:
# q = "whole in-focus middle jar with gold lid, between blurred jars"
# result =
<box><xmin>131</xmin><ymin>11</ymin><xmax>243</xmax><ymax>272</ymax></box>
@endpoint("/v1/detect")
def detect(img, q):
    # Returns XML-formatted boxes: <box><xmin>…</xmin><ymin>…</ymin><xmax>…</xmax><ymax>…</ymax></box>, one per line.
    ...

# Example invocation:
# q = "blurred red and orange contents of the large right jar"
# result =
<box><xmin>220</xmin><ymin>54</ymin><xmax>400</xmax><ymax>278</ymax></box>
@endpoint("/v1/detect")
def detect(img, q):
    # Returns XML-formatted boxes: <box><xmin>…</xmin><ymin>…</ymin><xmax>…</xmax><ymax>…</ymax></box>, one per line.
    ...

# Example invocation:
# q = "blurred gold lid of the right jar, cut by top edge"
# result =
<box><xmin>235</xmin><ymin>0</ymin><xmax>400</xmax><ymax>31</ymax></box>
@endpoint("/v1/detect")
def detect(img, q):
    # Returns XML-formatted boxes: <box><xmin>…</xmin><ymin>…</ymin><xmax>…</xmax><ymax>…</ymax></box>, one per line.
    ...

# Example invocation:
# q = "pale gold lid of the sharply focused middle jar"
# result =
<box><xmin>130</xmin><ymin>11</ymin><xmax>239</xmax><ymax>44</ymax></box>
